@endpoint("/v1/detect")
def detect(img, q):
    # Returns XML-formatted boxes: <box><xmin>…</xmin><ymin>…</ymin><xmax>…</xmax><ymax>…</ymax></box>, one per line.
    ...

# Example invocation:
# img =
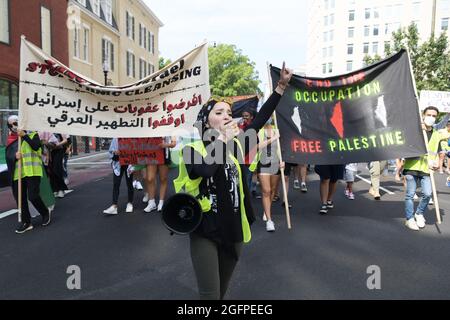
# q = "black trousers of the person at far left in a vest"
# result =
<box><xmin>13</xmin><ymin>177</ymin><xmax>48</xmax><ymax>223</ymax></box>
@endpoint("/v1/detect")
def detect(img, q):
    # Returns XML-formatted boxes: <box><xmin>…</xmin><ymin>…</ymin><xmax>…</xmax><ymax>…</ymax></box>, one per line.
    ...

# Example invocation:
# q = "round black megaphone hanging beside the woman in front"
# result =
<box><xmin>161</xmin><ymin>193</ymin><xmax>203</xmax><ymax>235</ymax></box>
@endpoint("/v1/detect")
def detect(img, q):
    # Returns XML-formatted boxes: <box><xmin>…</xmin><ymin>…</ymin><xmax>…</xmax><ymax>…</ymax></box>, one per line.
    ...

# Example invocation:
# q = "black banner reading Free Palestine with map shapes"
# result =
<box><xmin>270</xmin><ymin>50</ymin><xmax>426</xmax><ymax>164</ymax></box>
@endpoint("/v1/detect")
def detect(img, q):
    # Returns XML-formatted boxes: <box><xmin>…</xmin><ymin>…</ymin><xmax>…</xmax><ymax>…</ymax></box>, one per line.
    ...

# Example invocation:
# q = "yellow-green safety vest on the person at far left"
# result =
<box><xmin>14</xmin><ymin>132</ymin><xmax>43</xmax><ymax>181</ymax></box>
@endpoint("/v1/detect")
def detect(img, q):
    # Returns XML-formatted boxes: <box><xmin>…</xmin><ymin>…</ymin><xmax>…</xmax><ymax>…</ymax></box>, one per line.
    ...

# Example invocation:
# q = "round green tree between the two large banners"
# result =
<box><xmin>208</xmin><ymin>44</ymin><xmax>261</xmax><ymax>97</ymax></box>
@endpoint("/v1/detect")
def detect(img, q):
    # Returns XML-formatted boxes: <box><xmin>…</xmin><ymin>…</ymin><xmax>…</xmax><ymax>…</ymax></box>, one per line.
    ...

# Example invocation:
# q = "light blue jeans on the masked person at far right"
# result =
<box><xmin>405</xmin><ymin>174</ymin><xmax>432</xmax><ymax>220</ymax></box>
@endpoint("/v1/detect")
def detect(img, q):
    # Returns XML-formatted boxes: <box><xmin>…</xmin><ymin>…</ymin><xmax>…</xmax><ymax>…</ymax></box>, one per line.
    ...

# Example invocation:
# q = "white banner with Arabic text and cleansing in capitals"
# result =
<box><xmin>19</xmin><ymin>37</ymin><xmax>209</xmax><ymax>138</ymax></box>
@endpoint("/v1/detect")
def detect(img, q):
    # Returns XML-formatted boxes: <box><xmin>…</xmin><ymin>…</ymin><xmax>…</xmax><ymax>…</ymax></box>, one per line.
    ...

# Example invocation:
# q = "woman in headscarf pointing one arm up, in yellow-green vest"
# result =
<box><xmin>174</xmin><ymin>63</ymin><xmax>292</xmax><ymax>300</ymax></box>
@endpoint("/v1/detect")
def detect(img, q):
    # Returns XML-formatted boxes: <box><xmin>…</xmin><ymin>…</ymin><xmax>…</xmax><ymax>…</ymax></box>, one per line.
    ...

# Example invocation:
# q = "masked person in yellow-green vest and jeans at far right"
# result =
<box><xmin>403</xmin><ymin>106</ymin><xmax>450</xmax><ymax>231</ymax></box>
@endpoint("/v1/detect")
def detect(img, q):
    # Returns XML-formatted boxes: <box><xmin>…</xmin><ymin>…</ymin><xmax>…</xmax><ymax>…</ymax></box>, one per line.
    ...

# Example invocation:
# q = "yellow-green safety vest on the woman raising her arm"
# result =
<box><xmin>173</xmin><ymin>139</ymin><xmax>252</xmax><ymax>243</ymax></box>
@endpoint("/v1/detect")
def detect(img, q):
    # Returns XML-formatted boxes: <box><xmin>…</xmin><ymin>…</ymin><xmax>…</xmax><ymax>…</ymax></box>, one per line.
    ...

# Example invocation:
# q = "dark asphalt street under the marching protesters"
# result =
<box><xmin>0</xmin><ymin>165</ymin><xmax>450</xmax><ymax>300</ymax></box>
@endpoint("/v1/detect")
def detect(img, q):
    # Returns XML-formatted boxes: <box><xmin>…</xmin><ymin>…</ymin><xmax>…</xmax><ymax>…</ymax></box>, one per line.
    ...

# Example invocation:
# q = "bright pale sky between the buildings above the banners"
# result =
<box><xmin>144</xmin><ymin>0</ymin><xmax>307</xmax><ymax>90</ymax></box>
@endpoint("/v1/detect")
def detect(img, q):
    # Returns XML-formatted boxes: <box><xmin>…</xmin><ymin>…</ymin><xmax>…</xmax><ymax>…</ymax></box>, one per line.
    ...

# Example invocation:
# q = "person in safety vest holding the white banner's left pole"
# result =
<box><xmin>5</xmin><ymin>115</ymin><xmax>51</xmax><ymax>234</ymax></box>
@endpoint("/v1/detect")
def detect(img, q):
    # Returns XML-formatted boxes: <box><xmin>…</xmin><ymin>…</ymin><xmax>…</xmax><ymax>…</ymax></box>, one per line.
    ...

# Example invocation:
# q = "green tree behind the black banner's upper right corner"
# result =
<box><xmin>364</xmin><ymin>23</ymin><xmax>450</xmax><ymax>91</ymax></box>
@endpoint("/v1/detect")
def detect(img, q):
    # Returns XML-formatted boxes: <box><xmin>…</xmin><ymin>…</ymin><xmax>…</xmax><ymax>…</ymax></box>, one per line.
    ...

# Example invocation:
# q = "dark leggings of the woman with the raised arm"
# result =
<box><xmin>190</xmin><ymin>233</ymin><xmax>242</xmax><ymax>300</ymax></box>
